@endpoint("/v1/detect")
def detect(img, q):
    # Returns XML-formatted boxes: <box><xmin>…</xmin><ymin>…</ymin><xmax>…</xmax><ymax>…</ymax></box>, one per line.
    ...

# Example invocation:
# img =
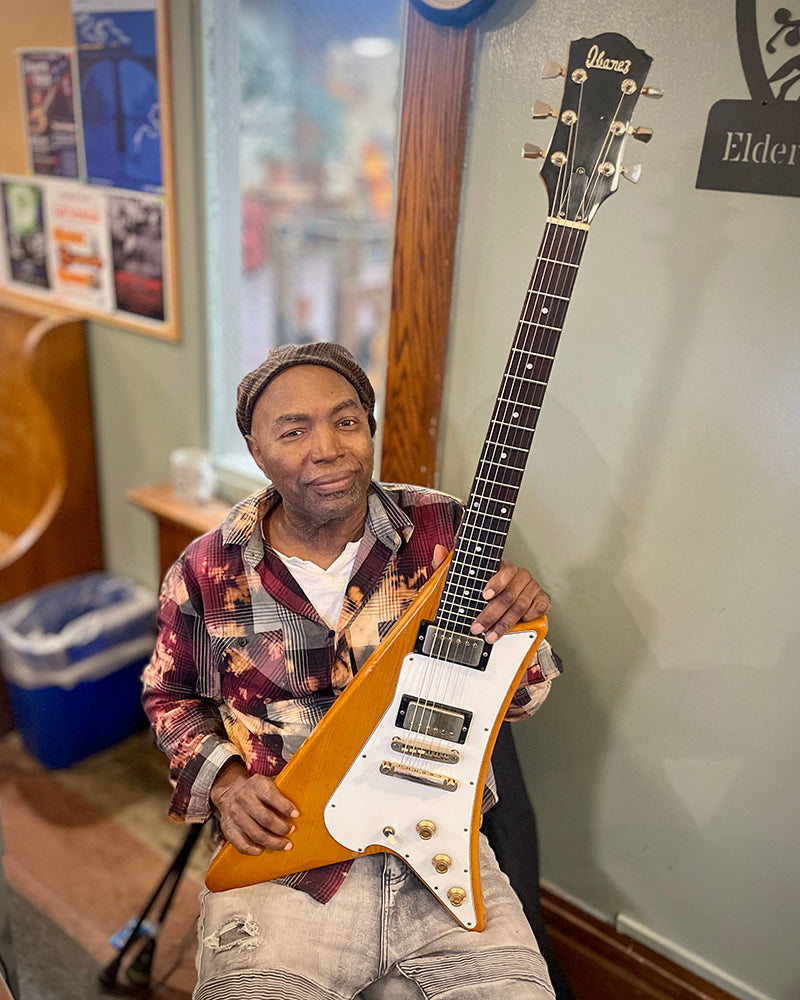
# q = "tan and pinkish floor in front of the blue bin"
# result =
<box><xmin>0</xmin><ymin>732</ymin><xmax>211</xmax><ymax>1000</ymax></box>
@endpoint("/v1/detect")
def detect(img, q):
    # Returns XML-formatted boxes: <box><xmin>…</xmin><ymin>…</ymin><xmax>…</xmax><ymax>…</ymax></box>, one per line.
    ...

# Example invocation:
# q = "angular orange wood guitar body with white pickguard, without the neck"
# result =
<box><xmin>206</xmin><ymin>559</ymin><xmax>546</xmax><ymax>930</ymax></box>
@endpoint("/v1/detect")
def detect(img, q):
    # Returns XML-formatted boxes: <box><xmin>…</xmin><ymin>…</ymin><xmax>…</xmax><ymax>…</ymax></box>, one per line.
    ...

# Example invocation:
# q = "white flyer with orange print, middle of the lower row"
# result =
<box><xmin>47</xmin><ymin>182</ymin><xmax>113</xmax><ymax>311</ymax></box>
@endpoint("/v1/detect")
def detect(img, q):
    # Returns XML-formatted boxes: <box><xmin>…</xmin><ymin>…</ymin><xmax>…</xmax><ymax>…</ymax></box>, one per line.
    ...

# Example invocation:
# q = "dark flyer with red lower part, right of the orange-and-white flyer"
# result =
<box><xmin>108</xmin><ymin>195</ymin><xmax>164</xmax><ymax>320</ymax></box>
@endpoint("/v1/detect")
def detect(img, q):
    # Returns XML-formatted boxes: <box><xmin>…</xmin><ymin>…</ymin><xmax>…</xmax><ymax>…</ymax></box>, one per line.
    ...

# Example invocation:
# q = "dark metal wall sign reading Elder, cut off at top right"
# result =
<box><xmin>697</xmin><ymin>0</ymin><xmax>800</xmax><ymax>197</ymax></box>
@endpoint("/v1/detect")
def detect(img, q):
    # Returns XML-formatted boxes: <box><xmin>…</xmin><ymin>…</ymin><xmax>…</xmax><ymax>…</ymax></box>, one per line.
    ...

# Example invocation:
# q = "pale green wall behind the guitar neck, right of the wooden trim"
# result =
<box><xmin>441</xmin><ymin>0</ymin><xmax>800</xmax><ymax>1000</ymax></box>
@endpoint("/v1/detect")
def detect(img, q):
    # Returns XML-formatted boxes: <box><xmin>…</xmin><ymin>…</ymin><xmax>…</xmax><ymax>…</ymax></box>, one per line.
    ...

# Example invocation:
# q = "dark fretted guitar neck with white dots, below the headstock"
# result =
<box><xmin>436</xmin><ymin>219</ymin><xmax>589</xmax><ymax>634</ymax></box>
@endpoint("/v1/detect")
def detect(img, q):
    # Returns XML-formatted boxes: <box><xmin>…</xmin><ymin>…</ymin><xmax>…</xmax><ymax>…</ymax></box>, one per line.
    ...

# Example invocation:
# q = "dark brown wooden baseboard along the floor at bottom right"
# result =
<box><xmin>541</xmin><ymin>886</ymin><xmax>734</xmax><ymax>1000</ymax></box>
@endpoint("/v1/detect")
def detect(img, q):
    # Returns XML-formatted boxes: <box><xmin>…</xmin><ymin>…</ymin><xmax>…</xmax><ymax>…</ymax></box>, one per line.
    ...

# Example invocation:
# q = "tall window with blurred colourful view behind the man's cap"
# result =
<box><xmin>202</xmin><ymin>0</ymin><xmax>402</xmax><ymax>479</ymax></box>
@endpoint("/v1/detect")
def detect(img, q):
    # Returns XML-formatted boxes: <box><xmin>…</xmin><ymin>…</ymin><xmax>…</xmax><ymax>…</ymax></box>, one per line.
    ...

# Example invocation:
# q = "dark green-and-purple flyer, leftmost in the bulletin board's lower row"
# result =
<box><xmin>0</xmin><ymin>179</ymin><xmax>50</xmax><ymax>290</ymax></box>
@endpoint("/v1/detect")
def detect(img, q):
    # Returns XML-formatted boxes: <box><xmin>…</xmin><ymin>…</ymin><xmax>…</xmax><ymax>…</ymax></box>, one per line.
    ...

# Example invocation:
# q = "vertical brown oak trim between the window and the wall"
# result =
<box><xmin>381</xmin><ymin>7</ymin><xmax>476</xmax><ymax>486</ymax></box>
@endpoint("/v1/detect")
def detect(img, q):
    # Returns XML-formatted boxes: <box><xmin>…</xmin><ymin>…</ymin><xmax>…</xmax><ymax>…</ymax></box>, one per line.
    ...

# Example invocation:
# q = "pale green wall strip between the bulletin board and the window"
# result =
<box><xmin>89</xmin><ymin>0</ymin><xmax>207</xmax><ymax>587</ymax></box>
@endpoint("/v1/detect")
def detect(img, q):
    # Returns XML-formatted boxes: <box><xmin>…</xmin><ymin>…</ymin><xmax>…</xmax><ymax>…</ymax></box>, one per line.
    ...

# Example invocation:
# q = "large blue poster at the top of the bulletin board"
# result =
<box><xmin>72</xmin><ymin>0</ymin><xmax>163</xmax><ymax>193</ymax></box>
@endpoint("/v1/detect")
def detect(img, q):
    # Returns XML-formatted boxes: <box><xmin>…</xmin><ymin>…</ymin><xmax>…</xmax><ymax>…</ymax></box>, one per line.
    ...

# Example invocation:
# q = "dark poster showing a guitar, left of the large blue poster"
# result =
<box><xmin>19</xmin><ymin>49</ymin><xmax>81</xmax><ymax>177</ymax></box>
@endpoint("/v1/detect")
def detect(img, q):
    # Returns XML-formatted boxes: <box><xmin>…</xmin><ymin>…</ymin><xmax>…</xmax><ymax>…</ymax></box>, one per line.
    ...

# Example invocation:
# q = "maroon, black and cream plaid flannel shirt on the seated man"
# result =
<box><xmin>143</xmin><ymin>483</ymin><xmax>560</xmax><ymax>902</ymax></box>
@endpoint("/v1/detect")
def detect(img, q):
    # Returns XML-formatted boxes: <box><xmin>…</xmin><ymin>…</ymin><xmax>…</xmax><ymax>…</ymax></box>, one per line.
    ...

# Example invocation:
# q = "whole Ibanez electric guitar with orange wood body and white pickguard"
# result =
<box><xmin>206</xmin><ymin>33</ymin><xmax>661</xmax><ymax>930</ymax></box>
